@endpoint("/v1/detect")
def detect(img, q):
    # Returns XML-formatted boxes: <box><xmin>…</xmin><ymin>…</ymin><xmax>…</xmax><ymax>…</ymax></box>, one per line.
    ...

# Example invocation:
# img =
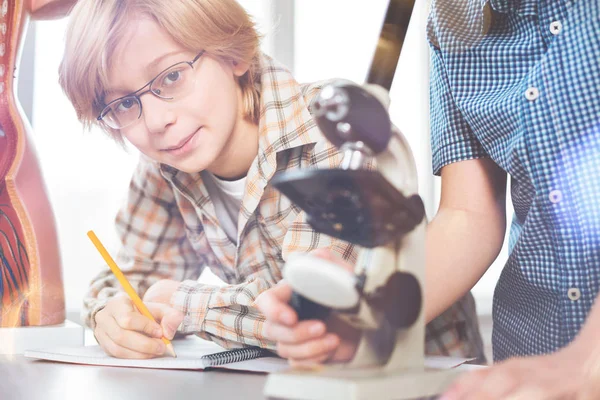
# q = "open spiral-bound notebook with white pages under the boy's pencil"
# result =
<box><xmin>25</xmin><ymin>336</ymin><xmax>480</xmax><ymax>373</ymax></box>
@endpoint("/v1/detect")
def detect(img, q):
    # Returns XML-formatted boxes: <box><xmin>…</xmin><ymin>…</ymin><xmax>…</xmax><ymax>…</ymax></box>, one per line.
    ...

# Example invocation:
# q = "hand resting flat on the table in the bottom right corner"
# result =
<box><xmin>440</xmin><ymin>345</ymin><xmax>600</xmax><ymax>400</ymax></box>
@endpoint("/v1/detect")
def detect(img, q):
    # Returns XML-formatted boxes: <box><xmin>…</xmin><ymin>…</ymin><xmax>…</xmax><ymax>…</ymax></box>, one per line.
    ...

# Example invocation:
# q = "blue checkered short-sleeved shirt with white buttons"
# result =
<box><xmin>428</xmin><ymin>0</ymin><xmax>600</xmax><ymax>360</ymax></box>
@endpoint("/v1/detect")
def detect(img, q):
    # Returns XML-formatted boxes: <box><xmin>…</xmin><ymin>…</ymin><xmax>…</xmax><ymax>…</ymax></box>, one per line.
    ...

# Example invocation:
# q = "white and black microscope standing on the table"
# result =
<box><xmin>265</xmin><ymin>0</ymin><xmax>457</xmax><ymax>400</ymax></box>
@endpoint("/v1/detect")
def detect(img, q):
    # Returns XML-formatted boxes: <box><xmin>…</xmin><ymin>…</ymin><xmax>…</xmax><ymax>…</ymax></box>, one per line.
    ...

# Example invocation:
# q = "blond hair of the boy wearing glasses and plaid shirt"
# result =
<box><xmin>59</xmin><ymin>0</ymin><xmax>260</xmax><ymax>139</ymax></box>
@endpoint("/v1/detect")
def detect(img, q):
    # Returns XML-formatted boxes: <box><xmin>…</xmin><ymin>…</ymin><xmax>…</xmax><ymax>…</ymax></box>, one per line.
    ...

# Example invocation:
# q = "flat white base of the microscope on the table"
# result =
<box><xmin>265</xmin><ymin>368</ymin><xmax>460</xmax><ymax>400</ymax></box>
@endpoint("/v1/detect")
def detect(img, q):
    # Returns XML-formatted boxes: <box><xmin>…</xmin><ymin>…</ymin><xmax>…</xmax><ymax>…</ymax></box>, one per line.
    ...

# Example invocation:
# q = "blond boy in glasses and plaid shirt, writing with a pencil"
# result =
<box><xmin>60</xmin><ymin>0</ymin><xmax>482</xmax><ymax>358</ymax></box>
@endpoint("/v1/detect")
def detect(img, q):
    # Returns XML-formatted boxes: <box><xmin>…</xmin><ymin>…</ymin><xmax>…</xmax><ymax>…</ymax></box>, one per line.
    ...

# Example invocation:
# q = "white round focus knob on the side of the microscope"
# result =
<box><xmin>283</xmin><ymin>254</ymin><xmax>360</xmax><ymax>310</ymax></box>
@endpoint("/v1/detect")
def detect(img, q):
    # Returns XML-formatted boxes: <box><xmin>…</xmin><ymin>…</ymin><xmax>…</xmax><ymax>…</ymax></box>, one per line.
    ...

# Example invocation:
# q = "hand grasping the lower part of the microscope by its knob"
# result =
<box><xmin>255</xmin><ymin>249</ymin><xmax>360</xmax><ymax>367</ymax></box>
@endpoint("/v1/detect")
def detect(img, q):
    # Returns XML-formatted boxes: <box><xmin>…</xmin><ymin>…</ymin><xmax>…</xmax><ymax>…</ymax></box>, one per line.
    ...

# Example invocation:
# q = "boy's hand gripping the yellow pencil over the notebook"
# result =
<box><xmin>94</xmin><ymin>294</ymin><xmax>183</xmax><ymax>359</ymax></box>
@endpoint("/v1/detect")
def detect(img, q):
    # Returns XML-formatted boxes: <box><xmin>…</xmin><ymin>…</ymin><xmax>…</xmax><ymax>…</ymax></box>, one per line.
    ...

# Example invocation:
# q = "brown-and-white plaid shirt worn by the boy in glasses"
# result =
<box><xmin>85</xmin><ymin>56</ymin><xmax>481</xmax><ymax>356</ymax></box>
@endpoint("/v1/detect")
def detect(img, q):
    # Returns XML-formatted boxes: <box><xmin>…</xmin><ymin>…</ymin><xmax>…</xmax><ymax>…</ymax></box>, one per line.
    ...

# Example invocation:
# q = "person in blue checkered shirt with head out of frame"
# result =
<box><xmin>258</xmin><ymin>0</ymin><xmax>600</xmax><ymax>400</ymax></box>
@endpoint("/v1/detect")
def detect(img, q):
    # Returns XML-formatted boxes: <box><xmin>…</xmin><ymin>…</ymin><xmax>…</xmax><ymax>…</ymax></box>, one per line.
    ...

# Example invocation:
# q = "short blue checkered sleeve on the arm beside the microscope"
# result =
<box><xmin>430</xmin><ymin>45</ymin><xmax>489</xmax><ymax>175</ymax></box>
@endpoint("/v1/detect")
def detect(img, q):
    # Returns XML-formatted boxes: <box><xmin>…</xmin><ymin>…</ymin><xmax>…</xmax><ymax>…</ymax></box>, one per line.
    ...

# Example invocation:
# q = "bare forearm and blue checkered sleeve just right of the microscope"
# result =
<box><xmin>425</xmin><ymin>38</ymin><xmax>506</xmax><ymax>321</ymax></box>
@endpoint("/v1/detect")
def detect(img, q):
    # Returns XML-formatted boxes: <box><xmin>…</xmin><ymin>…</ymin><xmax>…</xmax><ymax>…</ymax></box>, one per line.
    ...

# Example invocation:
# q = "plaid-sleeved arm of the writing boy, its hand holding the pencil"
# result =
<box><xmin>83</xmin><ymin>158</ymin><xmax>202</xmax><ymax>358</ymax></box>
